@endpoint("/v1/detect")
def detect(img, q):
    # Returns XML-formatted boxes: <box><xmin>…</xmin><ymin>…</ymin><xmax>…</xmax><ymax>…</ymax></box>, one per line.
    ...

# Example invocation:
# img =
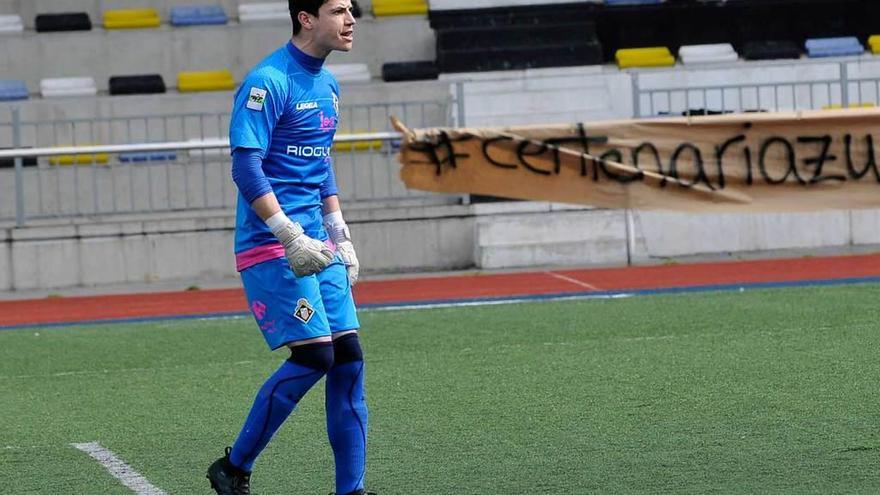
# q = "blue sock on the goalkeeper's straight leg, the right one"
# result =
<box><xmin>326</xmin><ymin>360</ymin><xmax>367</xmax><ymax>495</ymax></box>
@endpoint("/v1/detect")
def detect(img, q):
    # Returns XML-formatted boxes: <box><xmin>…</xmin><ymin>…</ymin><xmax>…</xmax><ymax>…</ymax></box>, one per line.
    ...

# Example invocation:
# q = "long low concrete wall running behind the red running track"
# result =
<box><xmin>6</xmin><ymin>202</ymin><xmax>880</xmax><ymax>291</ymax></box>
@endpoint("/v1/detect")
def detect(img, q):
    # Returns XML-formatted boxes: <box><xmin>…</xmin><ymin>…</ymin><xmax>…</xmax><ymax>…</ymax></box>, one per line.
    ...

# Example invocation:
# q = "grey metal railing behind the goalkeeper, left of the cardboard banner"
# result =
<box><xmin>0</xmin><ymin>99</ymin><xmax>461</xmax><ymax>226</ymax></box>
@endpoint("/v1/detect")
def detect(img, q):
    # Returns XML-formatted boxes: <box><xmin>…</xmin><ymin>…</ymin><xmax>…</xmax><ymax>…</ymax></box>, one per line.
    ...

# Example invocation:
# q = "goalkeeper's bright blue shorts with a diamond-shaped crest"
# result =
<box><xmin>241</xmin><ymin>255</ymin><xmax>360</xmax><ymax>349</ymax></box>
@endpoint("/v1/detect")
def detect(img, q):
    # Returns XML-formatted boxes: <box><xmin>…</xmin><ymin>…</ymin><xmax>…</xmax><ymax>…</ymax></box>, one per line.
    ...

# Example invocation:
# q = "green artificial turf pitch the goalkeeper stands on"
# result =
<box><xmin>0</xmin><ymin>285</ymin><xmax>880</xmax><ymax>495</ymax></box>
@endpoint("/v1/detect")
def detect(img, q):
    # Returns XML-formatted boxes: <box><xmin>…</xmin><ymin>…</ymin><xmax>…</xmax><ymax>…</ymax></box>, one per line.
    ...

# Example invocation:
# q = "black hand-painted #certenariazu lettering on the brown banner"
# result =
<box><xmin>409</xmin><ymin>124</ymin><xmax>880</xmax><ymax>190</ymax></box>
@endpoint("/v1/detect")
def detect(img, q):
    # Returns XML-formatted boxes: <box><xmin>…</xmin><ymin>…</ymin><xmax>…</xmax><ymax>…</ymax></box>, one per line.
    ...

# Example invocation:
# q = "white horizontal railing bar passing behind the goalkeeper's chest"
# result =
<box><xmin>0</xmin><ymin>132</ymin><xmax>402</xmax><ymax>158</ymax></box>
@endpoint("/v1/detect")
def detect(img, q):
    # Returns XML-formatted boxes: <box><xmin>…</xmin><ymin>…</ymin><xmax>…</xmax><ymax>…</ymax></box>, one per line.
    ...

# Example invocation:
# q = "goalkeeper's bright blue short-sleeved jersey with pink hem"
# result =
<box><xmin>229</xmin><ymin>42</ymin><xmax>339</xmax><ymax>271</ymax></box>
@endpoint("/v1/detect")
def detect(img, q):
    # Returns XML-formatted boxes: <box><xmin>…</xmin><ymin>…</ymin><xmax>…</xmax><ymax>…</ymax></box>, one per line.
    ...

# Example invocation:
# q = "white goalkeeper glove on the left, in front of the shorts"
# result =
<box><xmin>266</xmin><ymin>211</ymin><xmax>333</xmax><ymax>277</ymax></box>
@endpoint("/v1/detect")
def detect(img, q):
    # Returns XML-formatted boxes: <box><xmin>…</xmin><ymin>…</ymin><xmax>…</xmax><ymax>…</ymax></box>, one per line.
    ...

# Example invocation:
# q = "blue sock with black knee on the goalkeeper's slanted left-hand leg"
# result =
<box><xmin>229</xmin><ymin>342</ymin><xmax>333</xmax><ymax>472</ymax></box>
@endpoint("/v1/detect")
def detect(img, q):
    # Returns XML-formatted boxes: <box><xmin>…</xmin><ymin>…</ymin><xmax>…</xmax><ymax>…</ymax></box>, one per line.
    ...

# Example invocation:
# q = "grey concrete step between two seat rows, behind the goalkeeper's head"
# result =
<box><xmin>0</xmin><ymin>16</ymin><xmax>434</xmax><ymax>92</ymax></box>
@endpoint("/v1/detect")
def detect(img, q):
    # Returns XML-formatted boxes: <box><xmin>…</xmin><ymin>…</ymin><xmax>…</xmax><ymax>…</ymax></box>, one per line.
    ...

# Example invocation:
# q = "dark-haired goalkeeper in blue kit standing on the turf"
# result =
<box><xmin>207</xmin><ymin>0</ymin><xmax>367</xmax><ymax>495</ymax></box>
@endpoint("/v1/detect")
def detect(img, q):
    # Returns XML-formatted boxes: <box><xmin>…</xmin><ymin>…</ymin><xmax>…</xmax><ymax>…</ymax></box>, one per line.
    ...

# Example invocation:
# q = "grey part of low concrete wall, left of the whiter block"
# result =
<box><xmin>0</xmin><ymin>205</ymin><xmax>474</xmax><ymax>290</ymax></box>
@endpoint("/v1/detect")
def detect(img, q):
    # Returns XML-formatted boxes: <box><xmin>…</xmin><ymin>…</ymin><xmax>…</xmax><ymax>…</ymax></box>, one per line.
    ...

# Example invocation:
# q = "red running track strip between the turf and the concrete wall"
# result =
<box><xmin>0</xmin><ymin>254</ymin><xmax>880</xmax><ymax>327</ymax></box>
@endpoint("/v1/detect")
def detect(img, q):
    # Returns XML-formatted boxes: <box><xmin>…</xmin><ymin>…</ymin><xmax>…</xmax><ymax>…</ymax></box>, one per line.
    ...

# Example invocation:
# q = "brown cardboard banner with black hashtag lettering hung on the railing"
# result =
<box><xmin>394</xmin><ymin>109</ymin><xmax>880</xmax><ymax>213</ymax></box>
